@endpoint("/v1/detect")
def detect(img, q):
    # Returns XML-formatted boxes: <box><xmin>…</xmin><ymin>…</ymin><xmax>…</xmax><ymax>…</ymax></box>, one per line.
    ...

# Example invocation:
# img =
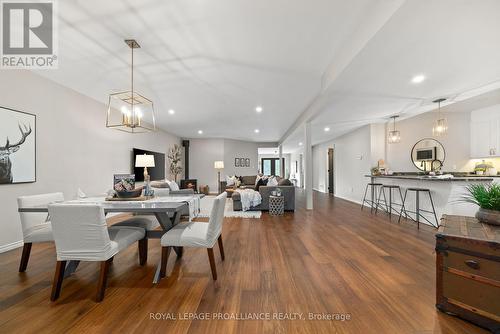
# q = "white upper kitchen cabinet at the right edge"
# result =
<box><xmin>470</xmin><ymin>106</ymin><xmax>500</xmax><ymax>158</ymax></box>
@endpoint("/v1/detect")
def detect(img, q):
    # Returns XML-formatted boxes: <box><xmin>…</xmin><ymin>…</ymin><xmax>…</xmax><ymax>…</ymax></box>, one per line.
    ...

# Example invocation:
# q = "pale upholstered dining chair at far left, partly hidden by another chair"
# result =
<box><xmin>17</xmin><ymin>192</ymin><xmax>64</xmax><ymax>273</ymax></box>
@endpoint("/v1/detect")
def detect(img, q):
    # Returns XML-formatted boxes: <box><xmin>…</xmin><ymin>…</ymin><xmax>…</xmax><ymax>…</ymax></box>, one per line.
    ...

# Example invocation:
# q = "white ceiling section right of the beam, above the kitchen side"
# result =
<box><xmin>284</xmin><ymin>0</ymin><xmax>500</xmax><ymax>152</ymax></box>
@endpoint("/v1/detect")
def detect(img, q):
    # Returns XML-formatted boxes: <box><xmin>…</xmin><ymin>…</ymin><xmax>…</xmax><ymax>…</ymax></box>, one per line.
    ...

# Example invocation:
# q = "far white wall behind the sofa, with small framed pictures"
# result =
<box><xmin>189</xmin><ymin>139</ymin><xmax>259</xmax><ymax>193</ymax></box>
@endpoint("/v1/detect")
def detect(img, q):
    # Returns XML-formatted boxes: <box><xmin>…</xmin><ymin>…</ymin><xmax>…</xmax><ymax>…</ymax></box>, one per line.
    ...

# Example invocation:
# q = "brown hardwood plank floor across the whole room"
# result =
<box><xmin>0</xmin><ymin>192</ymin><xmax>486</xmax><ymax>333</ymax></box>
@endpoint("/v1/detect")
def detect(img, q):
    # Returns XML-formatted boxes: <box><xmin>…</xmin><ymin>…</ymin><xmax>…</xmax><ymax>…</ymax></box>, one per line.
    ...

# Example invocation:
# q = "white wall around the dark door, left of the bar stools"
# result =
<box><xmin>313</xmin><ymin>125</ymin><xmax>380</xmax><ymax>202</ymax></box>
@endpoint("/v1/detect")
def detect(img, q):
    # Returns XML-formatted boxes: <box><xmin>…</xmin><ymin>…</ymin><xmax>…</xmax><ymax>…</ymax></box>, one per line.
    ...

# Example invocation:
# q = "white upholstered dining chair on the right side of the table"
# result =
<box><xmin>160</xmin><ymin>192</ymin><xmax>227</xmax><ymax>280</ymax></box>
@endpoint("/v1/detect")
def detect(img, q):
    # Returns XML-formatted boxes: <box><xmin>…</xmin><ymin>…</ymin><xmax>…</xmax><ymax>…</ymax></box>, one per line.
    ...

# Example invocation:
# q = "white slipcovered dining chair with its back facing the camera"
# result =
<box><xmin>49</xmin><ymin>203</ymin><xmax>145</xmax><ymax>302</ymax></box>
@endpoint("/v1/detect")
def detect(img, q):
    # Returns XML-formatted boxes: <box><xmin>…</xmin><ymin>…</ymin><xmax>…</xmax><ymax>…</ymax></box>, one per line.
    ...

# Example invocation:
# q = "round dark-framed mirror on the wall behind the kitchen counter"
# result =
<box><xmin>411</xmin><ymin>138</ymin><xmax>446</xmax><ymax>172</ymax></box>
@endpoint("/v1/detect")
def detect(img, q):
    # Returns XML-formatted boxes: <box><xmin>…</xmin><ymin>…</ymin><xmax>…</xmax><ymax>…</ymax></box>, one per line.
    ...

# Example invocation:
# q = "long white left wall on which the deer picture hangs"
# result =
<box><xmin>0</xmin><ymin>70</ymin><xmax>179</xmax><ymax>250</ymax></box>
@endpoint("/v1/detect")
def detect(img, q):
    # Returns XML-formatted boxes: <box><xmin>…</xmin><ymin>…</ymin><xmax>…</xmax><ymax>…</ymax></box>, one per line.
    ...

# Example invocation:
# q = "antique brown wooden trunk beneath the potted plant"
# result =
<box><xmin>436</xmin><ymin>215</ymin><xmax>500</xmax><ymax>333</ymax></box>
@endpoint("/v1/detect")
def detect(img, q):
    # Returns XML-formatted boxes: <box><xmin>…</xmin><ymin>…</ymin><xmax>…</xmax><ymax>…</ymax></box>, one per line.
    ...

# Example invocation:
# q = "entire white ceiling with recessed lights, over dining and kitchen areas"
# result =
<box><xmin>33</xmin><ymin>0</ymin><xmax>500</xmax><ymax>152</ymax></box>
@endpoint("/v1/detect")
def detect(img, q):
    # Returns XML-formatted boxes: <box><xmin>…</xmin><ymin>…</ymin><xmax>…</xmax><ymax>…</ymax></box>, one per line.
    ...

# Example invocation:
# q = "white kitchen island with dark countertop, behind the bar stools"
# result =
<box><xmin>366</xmin><ymin>173</ymin><xmax>500</xmax><ymax>224</ymax></box>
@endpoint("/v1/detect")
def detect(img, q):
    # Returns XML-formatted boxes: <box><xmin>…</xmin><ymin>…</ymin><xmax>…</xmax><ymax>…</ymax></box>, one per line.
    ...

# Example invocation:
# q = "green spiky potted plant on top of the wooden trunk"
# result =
<box><xmin>465</xmin><ymin>183</ymin><xmax>500</xmax><ymax>225</ymax></box>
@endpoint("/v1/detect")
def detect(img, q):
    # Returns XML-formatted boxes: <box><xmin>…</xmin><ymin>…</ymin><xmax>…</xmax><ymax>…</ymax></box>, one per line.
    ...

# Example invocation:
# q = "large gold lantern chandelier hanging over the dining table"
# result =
<box><xmin>106</xmin><ymin>39</ymin><xmax>156</xmax><ymax>133</ymax></box>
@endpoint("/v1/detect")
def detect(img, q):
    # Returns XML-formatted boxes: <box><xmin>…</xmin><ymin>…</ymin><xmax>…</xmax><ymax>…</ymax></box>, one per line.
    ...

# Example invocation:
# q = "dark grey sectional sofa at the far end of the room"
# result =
<box><xmin>221</xmin><ymin>175</ymin><xmax>295</xmax><ymax>211</ymax></box>
